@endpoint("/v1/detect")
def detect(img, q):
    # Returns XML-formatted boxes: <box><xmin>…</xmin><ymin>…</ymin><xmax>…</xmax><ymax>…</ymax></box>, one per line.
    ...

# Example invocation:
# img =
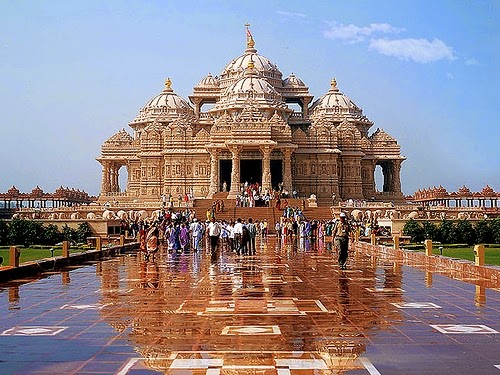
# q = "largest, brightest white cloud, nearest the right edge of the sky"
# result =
<box><xmin>370</xmin><ymin>38</ymin><xmax>456</xmax><ymax>64</ymax></box>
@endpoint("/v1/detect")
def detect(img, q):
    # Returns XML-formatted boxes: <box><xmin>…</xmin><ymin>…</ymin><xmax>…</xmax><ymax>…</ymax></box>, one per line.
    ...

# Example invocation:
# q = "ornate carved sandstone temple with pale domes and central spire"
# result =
<box><xmin>97</xmin><ymin>31</ymin><xmax>405</xmax><ymax>203</ymax></box>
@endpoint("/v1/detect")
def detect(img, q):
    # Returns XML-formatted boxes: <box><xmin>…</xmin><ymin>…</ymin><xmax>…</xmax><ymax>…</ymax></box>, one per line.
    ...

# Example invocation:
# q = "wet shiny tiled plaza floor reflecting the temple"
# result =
<box><xmin>0</xmin><ymin>238</ymin><xmax>500</xmax><ymax>375</ymax></box>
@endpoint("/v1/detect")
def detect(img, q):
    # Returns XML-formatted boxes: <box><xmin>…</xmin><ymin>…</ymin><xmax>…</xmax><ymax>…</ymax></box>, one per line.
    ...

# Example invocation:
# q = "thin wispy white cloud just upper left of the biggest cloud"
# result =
<box><xmin>323</xmin><ymin>22</ymin><xmax>404</xmax><ymax>44</ymax></box>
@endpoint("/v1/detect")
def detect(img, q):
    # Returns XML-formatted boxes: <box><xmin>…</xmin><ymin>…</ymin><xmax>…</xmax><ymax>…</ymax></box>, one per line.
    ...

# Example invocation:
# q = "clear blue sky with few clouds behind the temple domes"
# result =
<box><xmin>0</xmin><ymin>0</ymin><xmax>500</xmax><ymax>194</ymax></box>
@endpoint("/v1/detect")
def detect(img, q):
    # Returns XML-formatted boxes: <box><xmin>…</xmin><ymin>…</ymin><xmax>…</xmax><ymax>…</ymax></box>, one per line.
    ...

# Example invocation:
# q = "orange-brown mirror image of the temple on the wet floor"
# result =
<box><xmin>99</xmin><ymin>242</ymin><xmax>403</xmax><ymax>374</ymax></box>
